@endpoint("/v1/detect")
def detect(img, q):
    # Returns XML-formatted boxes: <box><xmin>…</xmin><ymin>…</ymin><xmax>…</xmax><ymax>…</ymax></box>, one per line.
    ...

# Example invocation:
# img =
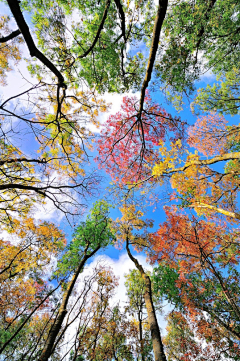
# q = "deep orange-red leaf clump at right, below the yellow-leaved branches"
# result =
<box><xmin>150</xmin><ymin>208</ymin><xmax>236</xmax><ymax>273</ymax></box>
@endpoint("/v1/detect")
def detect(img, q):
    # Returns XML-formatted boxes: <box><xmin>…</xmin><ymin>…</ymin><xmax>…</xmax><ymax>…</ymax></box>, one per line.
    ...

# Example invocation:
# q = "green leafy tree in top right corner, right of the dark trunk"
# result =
<box><xmin>155</xmin><ymin>0</ymin><xmax>239</xmax><ymax>112</ymax></box>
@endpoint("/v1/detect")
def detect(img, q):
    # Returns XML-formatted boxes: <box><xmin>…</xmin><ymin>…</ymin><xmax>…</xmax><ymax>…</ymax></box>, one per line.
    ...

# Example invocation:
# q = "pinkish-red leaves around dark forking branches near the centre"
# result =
<box><xmin>97</xmin><ymin>94</ymin><xmax>183</xmax><ymax>184</ymax></box>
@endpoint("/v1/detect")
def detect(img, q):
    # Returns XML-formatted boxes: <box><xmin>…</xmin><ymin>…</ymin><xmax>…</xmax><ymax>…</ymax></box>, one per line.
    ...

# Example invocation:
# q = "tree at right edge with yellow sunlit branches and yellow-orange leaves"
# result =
<box><xmin>150</xmin><ymin>114</ymin><xmax>239</xmax><ymax>219</ymax></box>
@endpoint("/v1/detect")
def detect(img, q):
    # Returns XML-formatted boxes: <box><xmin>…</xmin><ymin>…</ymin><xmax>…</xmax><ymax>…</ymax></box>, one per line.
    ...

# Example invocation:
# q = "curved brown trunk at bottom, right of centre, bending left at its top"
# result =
<box><xmin>126</xmin><ymin>237</ymin><xmax>167</xmax><ymax>361</ymax></box>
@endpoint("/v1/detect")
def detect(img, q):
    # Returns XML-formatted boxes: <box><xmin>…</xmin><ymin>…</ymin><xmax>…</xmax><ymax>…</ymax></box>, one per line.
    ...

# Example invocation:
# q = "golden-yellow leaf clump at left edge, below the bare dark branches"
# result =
<box><xmin>0</xmin><ymin>218</ymin><xmax>66</xmax><ymax>302</ymax></box>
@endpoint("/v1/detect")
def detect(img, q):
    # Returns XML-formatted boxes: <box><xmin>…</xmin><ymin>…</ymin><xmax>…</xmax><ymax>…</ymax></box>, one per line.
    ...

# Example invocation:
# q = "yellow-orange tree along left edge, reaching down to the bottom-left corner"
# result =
<box><xmin>0</xmin><ymin>218</ymin><xmax>66</xmax><ymax>359</ymax></box>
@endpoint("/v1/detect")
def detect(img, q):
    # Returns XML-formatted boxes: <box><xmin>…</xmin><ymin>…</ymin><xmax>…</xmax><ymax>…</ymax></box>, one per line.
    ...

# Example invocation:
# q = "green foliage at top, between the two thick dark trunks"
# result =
<box><xmin>22</xmin><ymin>0</ymin><xmax>154</xmax><ymax>92</ymax></box>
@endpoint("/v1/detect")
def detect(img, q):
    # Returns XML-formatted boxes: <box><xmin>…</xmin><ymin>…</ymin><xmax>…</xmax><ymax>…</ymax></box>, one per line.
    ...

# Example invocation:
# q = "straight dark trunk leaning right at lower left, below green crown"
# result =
<box><xmin>39</xmin><ymin>246</ymin><xmax>100</xmax><ymax>361</ymax></box>
